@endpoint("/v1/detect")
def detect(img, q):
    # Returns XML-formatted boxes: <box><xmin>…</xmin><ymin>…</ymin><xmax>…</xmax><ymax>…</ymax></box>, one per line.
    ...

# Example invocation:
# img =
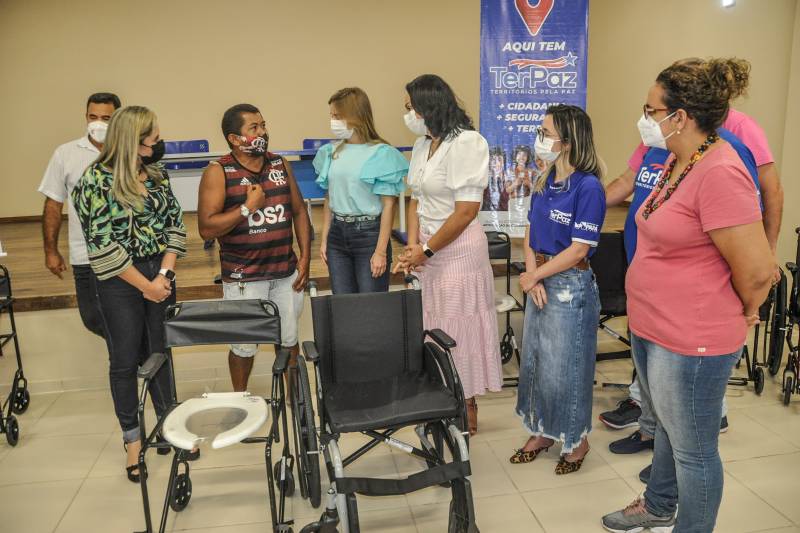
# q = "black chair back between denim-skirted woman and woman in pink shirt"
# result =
<box><xmin>592</xmin><ymin>232</ymin><xmax>628</xmax><ymax>316</ymax></box>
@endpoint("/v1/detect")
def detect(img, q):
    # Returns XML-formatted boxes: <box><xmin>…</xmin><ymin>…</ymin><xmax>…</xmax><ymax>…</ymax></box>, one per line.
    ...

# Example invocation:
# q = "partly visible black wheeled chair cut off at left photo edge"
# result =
<box><xmin>0</xmin><ymin>265</ymin><xmax>31</xmax><ymax>446</ymax></box>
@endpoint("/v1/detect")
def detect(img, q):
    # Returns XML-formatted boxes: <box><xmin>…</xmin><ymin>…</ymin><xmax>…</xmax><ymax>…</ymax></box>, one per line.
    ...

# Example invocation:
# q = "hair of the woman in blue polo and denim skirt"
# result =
<box><xmin>533</xmin><ymin>104</ymin><xmax>605</xmax><ymax>193</ymax></box>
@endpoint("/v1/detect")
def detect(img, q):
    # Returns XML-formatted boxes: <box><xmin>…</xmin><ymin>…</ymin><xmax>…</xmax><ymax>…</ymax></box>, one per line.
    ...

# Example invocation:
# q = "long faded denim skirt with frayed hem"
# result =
<box><xmin>516</xmin><ymin>268</ymin><xmax>600</xmax><ymax>454</ymax></box>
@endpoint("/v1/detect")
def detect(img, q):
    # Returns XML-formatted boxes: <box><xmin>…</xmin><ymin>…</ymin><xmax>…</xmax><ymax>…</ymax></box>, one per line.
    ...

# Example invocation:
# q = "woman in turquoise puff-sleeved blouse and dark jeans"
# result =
<box><xmin>314</xmin><ymin>87</ymin><xmax>408</xmax><ymax>294</ymax></box>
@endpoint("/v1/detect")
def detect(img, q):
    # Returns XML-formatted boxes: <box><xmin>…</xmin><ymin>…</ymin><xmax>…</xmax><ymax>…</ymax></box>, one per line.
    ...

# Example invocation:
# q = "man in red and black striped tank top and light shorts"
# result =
<box><xmin>197</xmin><ymin>104</ymin><xmax>311</xmax><ymax>392</ymax></box>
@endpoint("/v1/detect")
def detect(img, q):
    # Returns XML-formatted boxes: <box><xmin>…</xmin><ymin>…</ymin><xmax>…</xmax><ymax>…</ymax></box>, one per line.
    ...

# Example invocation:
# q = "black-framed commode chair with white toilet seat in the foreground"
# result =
<box><xmin>138</xmin><ymin>300</ymin><xmax>338</xmax><ymax>533</ymax></box>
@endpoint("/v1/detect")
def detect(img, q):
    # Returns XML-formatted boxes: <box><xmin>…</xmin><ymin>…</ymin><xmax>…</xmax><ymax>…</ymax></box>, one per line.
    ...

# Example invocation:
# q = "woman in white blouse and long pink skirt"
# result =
<box><xmin>394</xmin><ymin>74</ymin><xmax>503</xmax><ymax>435</ymax></box>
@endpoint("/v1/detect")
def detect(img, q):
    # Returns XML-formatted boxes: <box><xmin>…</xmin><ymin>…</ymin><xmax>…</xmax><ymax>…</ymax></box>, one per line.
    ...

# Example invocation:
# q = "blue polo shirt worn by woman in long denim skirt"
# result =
<box><xmin>528</xmin><ymin>171</ymin><xmax>606</xmax><ymax>257</ymax></box>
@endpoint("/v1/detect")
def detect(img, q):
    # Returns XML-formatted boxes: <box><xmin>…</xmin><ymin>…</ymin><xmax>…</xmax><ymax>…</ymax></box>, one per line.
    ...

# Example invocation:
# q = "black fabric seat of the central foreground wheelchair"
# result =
<box><xmin>324</xmin><ymin>374</ymin><xmax>459</xmax><ymax>433</ymax></box>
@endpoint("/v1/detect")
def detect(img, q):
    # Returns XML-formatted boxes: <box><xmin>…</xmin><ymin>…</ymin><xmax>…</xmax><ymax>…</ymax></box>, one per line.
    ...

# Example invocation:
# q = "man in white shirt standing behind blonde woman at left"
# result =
<box><xmin>39</xmin><ymin>89</ymin><xmax>121</xmax><ymax>337</ymax></box>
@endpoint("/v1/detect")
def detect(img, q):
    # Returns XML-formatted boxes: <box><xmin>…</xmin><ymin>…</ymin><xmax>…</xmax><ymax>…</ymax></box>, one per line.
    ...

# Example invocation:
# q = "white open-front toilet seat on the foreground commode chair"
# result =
<box><xmin>162</xmin><ymin>392</ymin><xmax>268</xmax><ymax>450</ymax></box>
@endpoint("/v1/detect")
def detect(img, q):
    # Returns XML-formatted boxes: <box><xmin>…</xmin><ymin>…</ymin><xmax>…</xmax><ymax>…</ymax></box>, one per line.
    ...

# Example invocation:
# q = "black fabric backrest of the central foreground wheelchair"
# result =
<box><xmin>311</xmin><ymin>290</ymin><xmax>423</xmax><ymax>384</ymax></box>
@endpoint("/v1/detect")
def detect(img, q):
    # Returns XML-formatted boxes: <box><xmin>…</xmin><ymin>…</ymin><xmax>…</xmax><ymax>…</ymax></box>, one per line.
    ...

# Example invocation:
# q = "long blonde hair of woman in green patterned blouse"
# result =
<box><xmin>96</xmin><ymin>106</ymin><xmax>163</xmax><ymax>210</ymax></box>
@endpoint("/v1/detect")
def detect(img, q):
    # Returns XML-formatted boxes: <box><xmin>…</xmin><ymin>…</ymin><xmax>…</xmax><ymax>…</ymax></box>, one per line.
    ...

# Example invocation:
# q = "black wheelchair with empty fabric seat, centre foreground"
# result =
<box><xmin>295</xmin><ymin>279</ymin><xmax>479</xmax><ymax>533</ymax></box>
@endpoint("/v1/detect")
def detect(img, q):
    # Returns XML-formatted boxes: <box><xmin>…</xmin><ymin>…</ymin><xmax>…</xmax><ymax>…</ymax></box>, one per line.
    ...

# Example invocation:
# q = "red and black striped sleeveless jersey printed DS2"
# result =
<box><xmin>217</xmin><ymin>152</ymin><xmax>297</xmax><ymax>282</ymax></box>
